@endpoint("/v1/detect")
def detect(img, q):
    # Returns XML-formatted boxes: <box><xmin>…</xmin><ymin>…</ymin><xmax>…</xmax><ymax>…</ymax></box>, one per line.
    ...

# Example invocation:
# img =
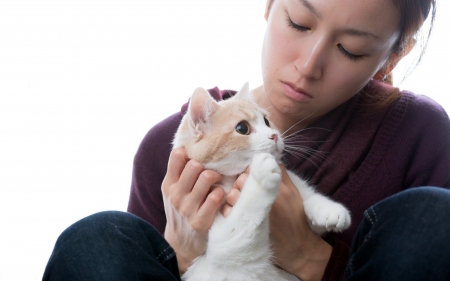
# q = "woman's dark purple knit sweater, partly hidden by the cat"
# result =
<box><xmin>128</xmin><ymin>81</ymin><xmax>450</xmax><ymax>280</ymax></box>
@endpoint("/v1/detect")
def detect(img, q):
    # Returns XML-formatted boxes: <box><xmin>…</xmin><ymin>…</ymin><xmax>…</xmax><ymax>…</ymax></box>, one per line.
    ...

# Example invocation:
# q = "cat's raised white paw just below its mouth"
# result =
<box><xmin>250</xmin><ymin>153</ymin><xmax>281</xmax><ymax>189</ymax></box>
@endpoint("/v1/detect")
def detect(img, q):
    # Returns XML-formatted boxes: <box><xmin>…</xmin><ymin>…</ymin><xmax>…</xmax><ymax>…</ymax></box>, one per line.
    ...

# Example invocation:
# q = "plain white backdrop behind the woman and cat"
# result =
<box><xmin>0</xmin><ymin>0</ymin><xmax>450</xmax><ymax>280</ymax></box>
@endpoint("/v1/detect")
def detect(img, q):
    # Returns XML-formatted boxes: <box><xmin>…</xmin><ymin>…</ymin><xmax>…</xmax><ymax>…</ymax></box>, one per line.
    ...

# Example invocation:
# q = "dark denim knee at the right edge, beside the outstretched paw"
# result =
<box><xmin>346</xmin><ymin>187</ymin><xmax>450</xmax><ymax>280</ymax></box>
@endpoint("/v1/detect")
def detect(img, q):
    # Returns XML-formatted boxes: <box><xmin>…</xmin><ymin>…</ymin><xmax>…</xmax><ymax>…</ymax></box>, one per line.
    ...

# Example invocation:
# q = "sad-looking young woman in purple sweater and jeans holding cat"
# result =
<box><xmin>44</xmin><ymin>0</ymin><xmax>450</xmax><ymax>281</ymax></box>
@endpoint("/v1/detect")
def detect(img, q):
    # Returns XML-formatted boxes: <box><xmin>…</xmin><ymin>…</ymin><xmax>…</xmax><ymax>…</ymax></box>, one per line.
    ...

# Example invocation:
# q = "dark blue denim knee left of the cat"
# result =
<box><xmin>43</xmin><ymin>211</ymin><xmax>179</xmax><ymax>280</ymax></box>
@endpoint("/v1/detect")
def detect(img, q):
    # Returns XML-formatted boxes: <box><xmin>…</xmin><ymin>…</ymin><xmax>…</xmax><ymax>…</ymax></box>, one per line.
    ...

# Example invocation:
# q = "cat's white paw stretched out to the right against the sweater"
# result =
<box><xmin>304</xmin><ymin>198</ymin><xmax>351</xmax><ymax>234</ymax></box>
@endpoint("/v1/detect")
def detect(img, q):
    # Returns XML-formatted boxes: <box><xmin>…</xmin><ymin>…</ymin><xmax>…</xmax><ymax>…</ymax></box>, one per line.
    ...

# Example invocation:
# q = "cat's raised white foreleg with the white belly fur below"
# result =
<box><xmin>183</xmin><ymin>153</ymin><xmax>298</xmax><ymax>281</ymax></box>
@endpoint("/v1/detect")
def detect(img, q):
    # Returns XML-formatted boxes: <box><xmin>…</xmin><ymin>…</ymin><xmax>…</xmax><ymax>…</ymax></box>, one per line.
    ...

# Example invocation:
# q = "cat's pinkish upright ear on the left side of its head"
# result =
<box><xmin>188</xmin><ymin>88</ymin><xmax>219</xmax><ymax>133</ymax></box>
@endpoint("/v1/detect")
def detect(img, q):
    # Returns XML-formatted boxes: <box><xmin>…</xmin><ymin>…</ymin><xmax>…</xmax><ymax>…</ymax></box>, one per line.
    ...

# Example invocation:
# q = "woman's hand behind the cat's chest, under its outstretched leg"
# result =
<box><xmin>221</xmin><ymin>165</ymin><xmax>332</xmax><ymax>281</ymax></box>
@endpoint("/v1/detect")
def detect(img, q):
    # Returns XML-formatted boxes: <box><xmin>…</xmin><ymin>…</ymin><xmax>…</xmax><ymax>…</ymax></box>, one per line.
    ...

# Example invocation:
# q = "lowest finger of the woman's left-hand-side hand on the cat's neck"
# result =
<box><xmin>191</xmin><ymin>186</ymin><xmax>225</xmax><ymax>231</ymax></box>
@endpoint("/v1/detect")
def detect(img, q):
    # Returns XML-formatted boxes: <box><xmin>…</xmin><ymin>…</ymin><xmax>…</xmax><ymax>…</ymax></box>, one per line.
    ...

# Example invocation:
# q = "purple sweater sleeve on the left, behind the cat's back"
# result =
<box><xmin>128</xmin><ymin>113</ymin><xmax>182</xmax><ymax>233</ymax></box>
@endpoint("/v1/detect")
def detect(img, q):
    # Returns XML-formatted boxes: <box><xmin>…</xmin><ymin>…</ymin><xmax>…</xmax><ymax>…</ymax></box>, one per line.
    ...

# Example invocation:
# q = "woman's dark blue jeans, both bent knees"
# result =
<box><xmin>43</xmin><ymin>187</ymin><xmax>450</xmax><ymax>281</ymax></box>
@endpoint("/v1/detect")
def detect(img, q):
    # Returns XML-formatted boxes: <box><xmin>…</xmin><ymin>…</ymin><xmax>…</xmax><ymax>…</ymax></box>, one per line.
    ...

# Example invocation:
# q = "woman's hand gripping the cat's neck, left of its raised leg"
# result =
<box><xmin>162</xmin><ymin>148</ymin><xmax>225</xmax><ymax>273</ymax></box>
